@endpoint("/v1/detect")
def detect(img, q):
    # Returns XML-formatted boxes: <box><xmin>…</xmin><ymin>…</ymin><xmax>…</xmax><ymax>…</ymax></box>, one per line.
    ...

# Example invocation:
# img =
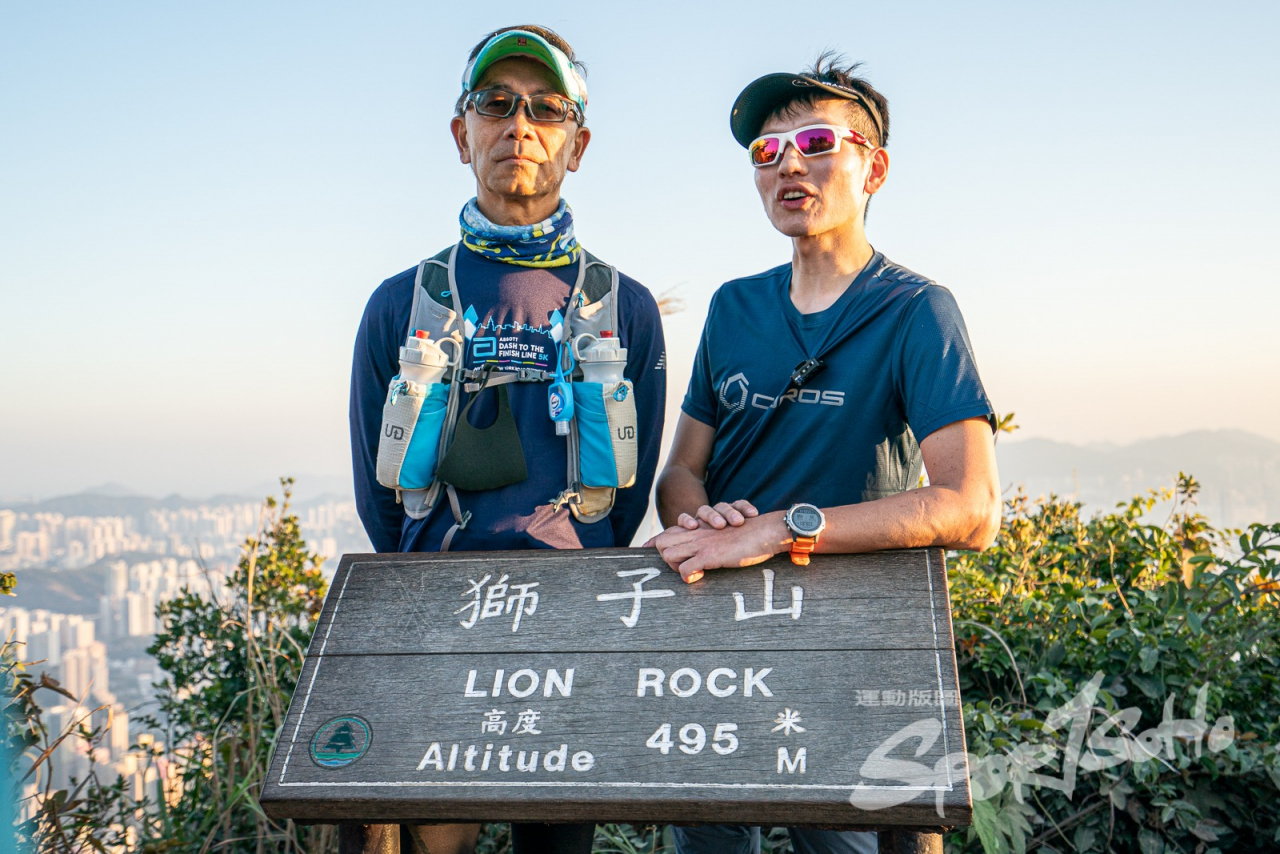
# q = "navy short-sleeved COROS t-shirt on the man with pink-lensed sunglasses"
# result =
<box><xmin>682</xmin><ymin>252</ymin><xmax>992</xmax><ymax>512</ymax></box>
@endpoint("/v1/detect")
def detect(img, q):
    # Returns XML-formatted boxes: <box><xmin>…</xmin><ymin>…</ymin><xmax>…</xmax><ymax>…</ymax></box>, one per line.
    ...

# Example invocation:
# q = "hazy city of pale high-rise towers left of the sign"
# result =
<box><xmin>0</xmin><ymin>498</ymin><xmax>370</xmax><ymax>808</ymax></box>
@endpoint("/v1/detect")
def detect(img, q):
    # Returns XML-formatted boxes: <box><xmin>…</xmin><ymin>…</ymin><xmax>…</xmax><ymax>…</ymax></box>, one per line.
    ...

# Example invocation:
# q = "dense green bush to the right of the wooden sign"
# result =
<box><xmin>947</xmin><ymin>475</ymin><xmax>1280</xmax><ymax>854</ymax></box>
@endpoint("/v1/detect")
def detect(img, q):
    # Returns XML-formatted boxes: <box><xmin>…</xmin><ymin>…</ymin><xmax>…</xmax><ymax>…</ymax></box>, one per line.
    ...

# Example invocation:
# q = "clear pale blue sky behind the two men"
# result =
<box><xmin>0</xmin><ymin>0</ymin><xmax>1280</xmax><ymax>498</ymax></box>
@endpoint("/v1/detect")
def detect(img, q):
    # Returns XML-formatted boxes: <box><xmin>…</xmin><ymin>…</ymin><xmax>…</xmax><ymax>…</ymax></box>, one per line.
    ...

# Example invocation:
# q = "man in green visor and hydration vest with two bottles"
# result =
<box><xmin>351</xmin><ymin>26</ymin><xmax>666</xmax><ymax>854</ymax></box>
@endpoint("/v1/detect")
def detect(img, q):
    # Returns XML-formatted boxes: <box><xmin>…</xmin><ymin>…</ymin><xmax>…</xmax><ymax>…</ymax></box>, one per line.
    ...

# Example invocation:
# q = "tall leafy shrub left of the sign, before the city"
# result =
<box><xmin>146</xmin><ymin>479</ymin><xmax>337</xmax><ymax>854</ymax></box>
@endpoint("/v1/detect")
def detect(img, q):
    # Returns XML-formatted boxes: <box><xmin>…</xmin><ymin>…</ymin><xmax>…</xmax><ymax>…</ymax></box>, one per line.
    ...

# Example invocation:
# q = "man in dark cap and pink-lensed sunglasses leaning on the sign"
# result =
<box><xmin>652</xmin><ymin>56</ymin><xmax>1000</xmax><ymax>854</ymax></box>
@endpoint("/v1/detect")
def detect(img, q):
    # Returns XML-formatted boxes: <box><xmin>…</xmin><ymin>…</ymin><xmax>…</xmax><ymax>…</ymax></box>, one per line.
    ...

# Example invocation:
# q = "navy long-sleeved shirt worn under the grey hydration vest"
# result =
<box><xmin>351</xmin><ymin>248</ymin><xmax>667</xmax><ymax>552</ymax></box>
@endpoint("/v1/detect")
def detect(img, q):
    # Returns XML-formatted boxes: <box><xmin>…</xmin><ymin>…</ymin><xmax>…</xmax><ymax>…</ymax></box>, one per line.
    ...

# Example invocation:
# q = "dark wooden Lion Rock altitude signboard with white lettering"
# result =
<box><xmin>261</xmin><ymin>549</ymin><xmax>972</xmax><ymax>827</ymax></box>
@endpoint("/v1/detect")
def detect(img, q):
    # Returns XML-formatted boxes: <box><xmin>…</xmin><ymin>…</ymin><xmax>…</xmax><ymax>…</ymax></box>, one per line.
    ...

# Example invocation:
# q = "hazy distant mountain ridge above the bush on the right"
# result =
<box><xmin>996</xmin><ymin>430</ymin><xmax>1280</xmax><ymax>528</ymax></box>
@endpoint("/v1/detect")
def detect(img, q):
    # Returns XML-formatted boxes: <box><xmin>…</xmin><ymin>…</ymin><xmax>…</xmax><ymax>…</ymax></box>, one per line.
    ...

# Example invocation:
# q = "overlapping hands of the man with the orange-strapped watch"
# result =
<box><xmin>645</xmin><ymin>512</ymin><xmax>791</xmax><ymax>584</ymax></box>
